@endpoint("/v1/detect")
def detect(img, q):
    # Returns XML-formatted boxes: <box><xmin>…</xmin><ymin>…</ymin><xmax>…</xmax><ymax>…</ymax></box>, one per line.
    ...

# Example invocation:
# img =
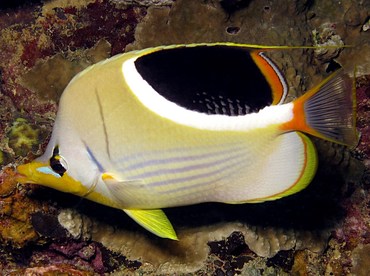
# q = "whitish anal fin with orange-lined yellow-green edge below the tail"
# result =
<box><xmin>223</xmin><ymin>132</ymin><xmax>317</xmax><ymax>204</ymax></box>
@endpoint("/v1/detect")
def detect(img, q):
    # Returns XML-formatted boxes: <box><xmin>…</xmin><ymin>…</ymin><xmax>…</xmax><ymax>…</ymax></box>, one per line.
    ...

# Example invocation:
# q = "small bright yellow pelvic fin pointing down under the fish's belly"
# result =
<box><xmin>123</xmin><ymin>209</ymin><xmax>178</xmax><ymax>240</ymax></box>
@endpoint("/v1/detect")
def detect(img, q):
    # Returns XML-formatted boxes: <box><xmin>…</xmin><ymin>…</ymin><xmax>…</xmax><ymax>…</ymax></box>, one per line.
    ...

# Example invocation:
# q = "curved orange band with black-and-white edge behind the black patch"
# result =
<box><xmin>251</xmin><ymin>50</ymin><xmax>288</xmax><ymax>105</ymax></box>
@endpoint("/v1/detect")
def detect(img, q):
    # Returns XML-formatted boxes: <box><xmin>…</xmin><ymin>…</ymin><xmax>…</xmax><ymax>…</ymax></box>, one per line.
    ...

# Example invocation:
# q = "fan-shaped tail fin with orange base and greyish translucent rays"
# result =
<box><xmin>284</xmin><ymin>70</ymin><xmax>358</xmax><ymax>147</ymax></box>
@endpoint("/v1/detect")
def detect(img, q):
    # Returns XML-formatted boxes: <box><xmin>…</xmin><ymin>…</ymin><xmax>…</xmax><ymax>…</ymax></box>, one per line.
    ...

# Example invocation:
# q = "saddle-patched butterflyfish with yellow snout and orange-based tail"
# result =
<box><xmin>17</xmin><ymin>42</ymin><xmax>358</xmax><ymax>240</ymax></box>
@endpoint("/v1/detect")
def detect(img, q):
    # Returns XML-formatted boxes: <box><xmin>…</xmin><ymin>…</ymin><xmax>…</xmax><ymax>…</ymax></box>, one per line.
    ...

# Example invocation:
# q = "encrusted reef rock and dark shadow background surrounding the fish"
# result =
<box><xmin>0</xmin><ymin>0</ymin><xmax>370</xmax><ymax>275</ymax></box>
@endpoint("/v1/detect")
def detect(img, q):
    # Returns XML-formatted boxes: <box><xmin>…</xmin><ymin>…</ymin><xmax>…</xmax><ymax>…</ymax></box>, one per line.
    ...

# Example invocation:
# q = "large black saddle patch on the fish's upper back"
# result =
<box><xmin>135</xmin><ymin>45</ymin><xmax>273</xmax><ymax>116</ymax></box>
